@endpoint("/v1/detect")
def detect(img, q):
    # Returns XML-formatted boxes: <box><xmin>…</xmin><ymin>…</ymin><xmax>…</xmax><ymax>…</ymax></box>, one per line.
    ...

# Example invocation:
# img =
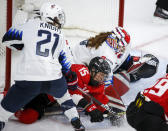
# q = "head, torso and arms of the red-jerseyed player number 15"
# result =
<box><xmin>68</xmin><ymin>57</ymin><xmax>111</xmax><ymax>122</ymax></box>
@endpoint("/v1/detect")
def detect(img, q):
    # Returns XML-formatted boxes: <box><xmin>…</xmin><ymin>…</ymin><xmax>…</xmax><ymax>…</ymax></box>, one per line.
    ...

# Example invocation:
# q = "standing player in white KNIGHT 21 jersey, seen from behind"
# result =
<box><xmin>0</xmin><ymin>2</ymin><xmax>85</xmax><ymax>131</ymax></box>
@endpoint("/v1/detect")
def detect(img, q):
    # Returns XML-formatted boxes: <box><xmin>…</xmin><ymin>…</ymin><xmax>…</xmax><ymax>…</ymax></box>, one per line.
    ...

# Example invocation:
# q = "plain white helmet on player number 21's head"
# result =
<box><xmin>40</xmin><ymin>2</ymin><xmax>65</xmax><ymax>28</ymax></box>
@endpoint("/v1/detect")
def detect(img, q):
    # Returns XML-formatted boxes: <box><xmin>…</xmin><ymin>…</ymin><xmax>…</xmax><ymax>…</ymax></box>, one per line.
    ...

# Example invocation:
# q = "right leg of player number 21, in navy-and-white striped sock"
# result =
<box><xmin>48</xmin><ymin>77</ymin><xmax>85</xmax><ymax>131</ymax></box>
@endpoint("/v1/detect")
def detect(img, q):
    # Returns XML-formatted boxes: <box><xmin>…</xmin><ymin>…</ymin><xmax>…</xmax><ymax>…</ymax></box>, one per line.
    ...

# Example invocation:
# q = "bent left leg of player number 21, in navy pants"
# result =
<box><xmin>0</xmin><ymin>81</ymin><xmax>40</xmax><ymax>129</ymax></box>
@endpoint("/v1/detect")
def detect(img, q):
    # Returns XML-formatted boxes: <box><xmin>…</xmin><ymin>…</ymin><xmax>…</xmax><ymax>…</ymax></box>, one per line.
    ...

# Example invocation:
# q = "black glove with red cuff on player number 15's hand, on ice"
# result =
<box><xmin>86</xmin><ymin>104</ymin><xmax>104</xmax><ymax>122</ymax></box>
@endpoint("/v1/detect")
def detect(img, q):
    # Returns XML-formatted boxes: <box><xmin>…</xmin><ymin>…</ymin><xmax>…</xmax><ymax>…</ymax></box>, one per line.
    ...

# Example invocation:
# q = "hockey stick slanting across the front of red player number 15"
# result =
<box><xmin>77</xmin><ymin>87</ymin><xmax>125</xmax><ymax>116</ymax></box>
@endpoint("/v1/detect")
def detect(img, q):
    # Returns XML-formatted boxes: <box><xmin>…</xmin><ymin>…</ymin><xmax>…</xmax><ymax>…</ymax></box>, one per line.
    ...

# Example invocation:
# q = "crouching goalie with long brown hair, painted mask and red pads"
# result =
<box><xmin>72</xmin><ymin>27</ymin><xmax>159</xmax><ymax>110</ymax></box>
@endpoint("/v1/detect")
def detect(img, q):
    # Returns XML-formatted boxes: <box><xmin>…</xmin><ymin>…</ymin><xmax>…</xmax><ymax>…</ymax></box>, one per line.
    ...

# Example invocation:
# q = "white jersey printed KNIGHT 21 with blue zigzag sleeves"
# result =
<box><xmin>2</xmin><ymin>19</ymin><xmax>72</xmax><ymax>81</ymax></box>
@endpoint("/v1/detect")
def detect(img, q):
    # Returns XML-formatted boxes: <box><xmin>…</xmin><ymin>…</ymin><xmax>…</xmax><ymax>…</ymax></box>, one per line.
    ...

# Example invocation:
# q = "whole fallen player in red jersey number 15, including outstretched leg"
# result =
<box><xmin>15</xmin><ymin>57</ymin><xmax>111</xmax><ymax>124</ymax></box>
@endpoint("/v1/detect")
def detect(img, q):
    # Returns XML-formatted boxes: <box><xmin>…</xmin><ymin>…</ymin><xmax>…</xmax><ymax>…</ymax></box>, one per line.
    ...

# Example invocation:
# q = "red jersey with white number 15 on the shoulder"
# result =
<box><xmin>69</xmin><ymin>64</ymin><xmax>109</xmax><ymax>111</ymax></box>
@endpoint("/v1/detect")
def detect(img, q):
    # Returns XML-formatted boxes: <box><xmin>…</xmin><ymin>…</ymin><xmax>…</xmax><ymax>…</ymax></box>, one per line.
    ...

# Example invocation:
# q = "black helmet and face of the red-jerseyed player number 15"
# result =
<box><xmin>89</xmin><ymin>57</ymin><xmax>111</xmax><ymax>86</ymax></box>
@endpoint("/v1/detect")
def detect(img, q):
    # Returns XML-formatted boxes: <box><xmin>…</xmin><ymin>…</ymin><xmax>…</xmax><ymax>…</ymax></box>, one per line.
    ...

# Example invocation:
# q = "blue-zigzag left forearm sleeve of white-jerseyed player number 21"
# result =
<box><xmin>2</xmin><ymin>26</ymin><xmax>24</xmax><ymax>50</ymax></box>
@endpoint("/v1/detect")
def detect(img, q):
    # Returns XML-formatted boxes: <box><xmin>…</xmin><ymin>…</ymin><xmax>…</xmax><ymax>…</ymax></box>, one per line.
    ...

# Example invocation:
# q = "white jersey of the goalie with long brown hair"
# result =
<box><xmin>72</xmin><ymin>40</ymin><xmax>130</xmax><ymax>86</ymax></box>
